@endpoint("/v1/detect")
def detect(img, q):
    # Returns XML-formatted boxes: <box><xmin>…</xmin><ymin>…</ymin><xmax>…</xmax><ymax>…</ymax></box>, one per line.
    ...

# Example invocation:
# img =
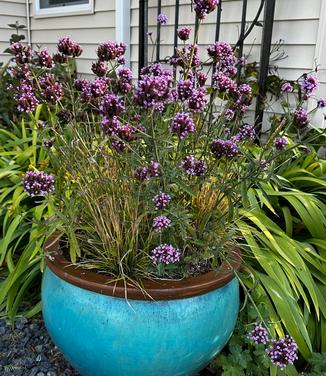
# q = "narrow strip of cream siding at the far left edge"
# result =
<box><xmin>0</xmin><ymin>0</ymin><xmax>27</xmax><ymax>62</ymax></box>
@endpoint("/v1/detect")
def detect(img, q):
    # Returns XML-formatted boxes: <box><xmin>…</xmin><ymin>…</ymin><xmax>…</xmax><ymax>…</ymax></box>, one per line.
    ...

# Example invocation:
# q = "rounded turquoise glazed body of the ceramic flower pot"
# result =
<box><xmin>42</xmin><ymin>238</ymin><xmax>239</xmax><ymax>376</ymax></box>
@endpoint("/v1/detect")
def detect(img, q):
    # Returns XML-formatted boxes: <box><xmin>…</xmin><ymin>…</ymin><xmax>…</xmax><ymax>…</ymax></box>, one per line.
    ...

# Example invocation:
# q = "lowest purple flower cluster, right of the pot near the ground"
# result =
<box><xmin>266</xmin><ymin>336</ymin><xmax>298</xmax><ymax>368</ymax></box>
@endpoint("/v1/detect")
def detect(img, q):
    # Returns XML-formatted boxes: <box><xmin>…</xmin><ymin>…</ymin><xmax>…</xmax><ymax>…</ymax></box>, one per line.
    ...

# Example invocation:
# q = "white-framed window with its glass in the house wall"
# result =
<box><xmin>34</xmin><ymin>0</ymin><xmax>94</xmax><ymax>17</ymax></box>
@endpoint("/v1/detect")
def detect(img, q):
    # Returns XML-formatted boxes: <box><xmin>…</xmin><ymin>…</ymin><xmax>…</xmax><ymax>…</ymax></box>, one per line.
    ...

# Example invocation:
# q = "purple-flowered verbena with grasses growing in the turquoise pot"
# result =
<box><xmin>10</xmin><ymin>0</ymin><xmax>325</xmax><ymax>281</ymax></box>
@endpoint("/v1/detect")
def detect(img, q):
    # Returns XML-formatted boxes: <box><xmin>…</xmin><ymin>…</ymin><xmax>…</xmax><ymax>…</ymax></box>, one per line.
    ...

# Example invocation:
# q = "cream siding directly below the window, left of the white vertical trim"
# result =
<box><xmin>30</xmin><ymin>0</ymin><xmax>115</xmax><ymax>76</ymax></box>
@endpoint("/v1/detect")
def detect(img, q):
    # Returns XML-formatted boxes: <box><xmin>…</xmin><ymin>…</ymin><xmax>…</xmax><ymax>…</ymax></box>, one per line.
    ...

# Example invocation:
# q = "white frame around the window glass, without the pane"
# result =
<box><xmin>34</xmin><ymin>0</ymin><xmax>94</xmax><ymax>18</ymax></box>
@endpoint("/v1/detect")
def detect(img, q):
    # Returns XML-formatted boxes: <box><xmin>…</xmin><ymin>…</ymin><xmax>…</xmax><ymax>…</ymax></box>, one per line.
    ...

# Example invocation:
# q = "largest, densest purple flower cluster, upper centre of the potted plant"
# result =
<box><xmin>134</xmin><ymin>64</ymin><xmax>172</xmax><ymax>111</ymax></box>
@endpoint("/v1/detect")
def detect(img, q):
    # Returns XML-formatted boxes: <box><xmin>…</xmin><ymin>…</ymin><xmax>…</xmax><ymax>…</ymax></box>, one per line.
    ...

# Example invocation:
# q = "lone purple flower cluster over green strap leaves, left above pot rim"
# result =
<box><xmin>23</xmin><ymin>171</ymin><xmax>54</xmax><ymax>197</ymax></box>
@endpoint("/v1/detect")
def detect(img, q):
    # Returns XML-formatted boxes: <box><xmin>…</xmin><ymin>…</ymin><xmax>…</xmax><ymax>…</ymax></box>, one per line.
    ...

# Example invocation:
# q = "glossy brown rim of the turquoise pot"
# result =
<box><xmin>45</xmin><ymin>235</ymin><xmax>241</xmax><ymax>300</ymax></box>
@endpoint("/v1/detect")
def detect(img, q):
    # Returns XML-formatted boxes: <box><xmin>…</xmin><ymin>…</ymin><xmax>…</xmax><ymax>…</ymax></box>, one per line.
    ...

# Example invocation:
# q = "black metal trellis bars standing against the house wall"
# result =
<box><xmin>139</xmin><ymin>0</ymin><xmax>276</xmax><ymax>132</ymax></box>
